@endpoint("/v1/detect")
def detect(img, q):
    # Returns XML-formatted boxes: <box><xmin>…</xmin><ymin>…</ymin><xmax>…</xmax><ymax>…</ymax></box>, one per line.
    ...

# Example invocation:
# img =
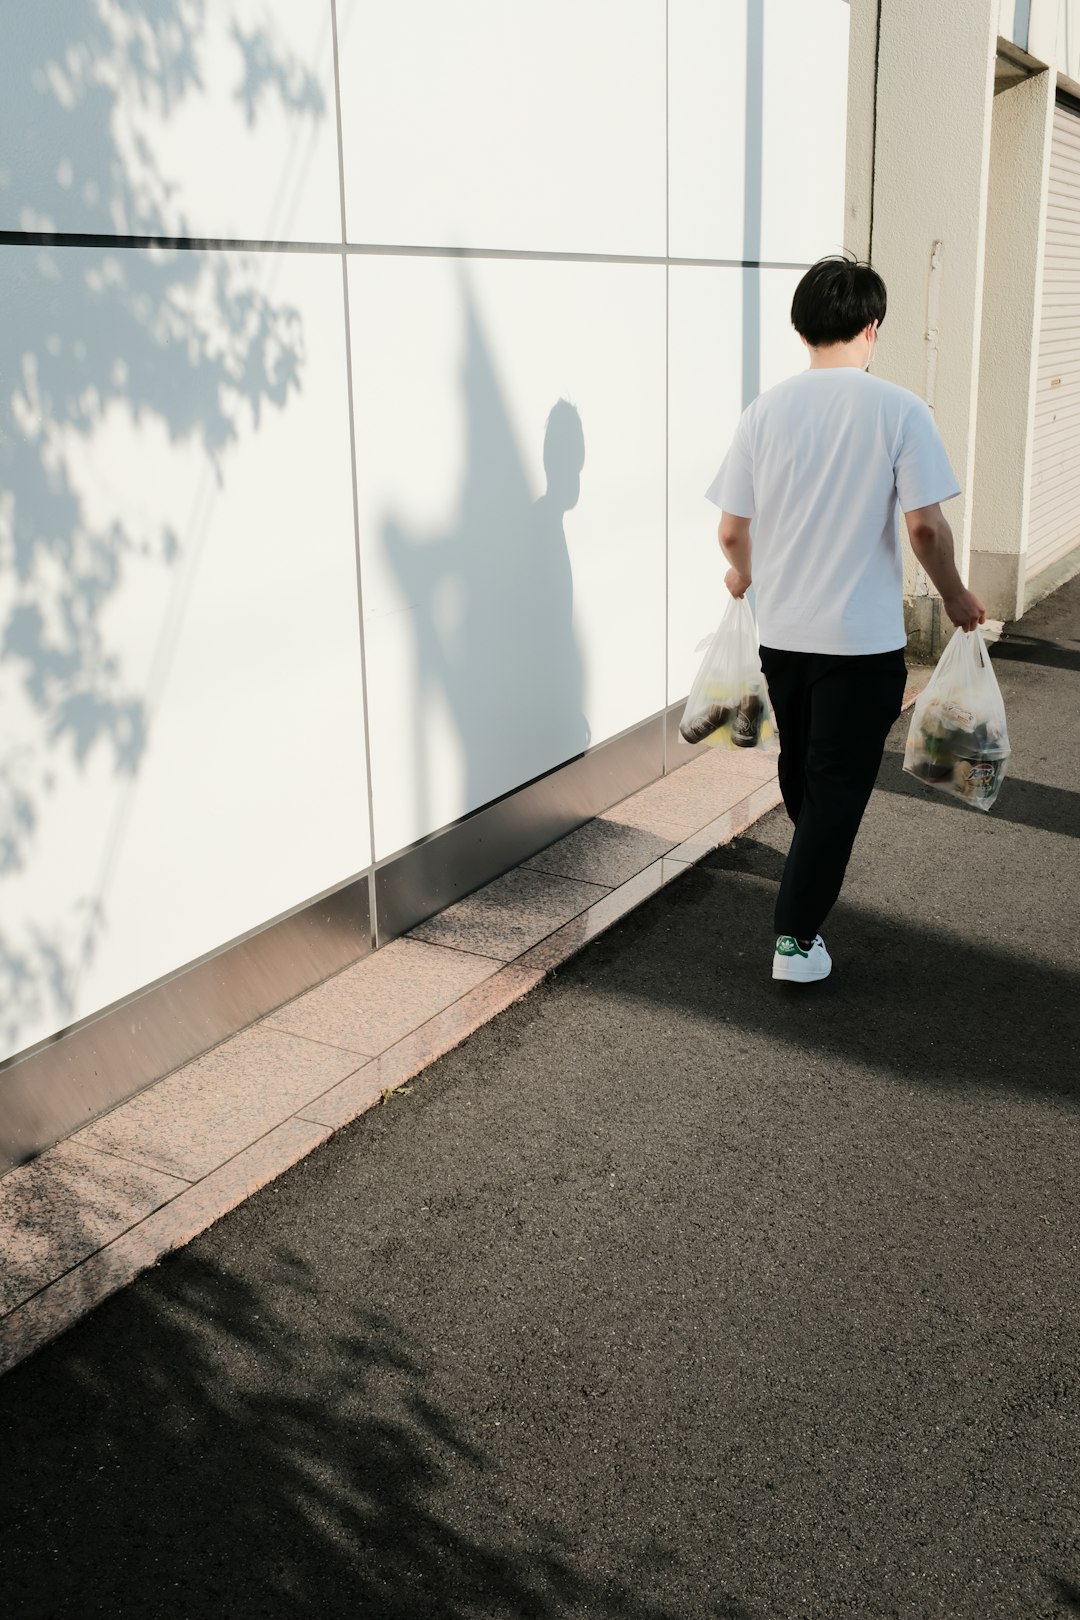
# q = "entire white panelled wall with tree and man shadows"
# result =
<box><xmin>0</xmin><ymin>0</ymin><xmax>848</xmax><ymax>1058</ymax></box>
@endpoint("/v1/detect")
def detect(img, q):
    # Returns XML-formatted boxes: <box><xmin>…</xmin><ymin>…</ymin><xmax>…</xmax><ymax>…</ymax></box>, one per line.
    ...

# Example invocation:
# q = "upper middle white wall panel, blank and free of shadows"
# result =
<box><xmin>338</xmin><ymin>0</ymin><xmax>665</xmax><ymax>254</ymax></box>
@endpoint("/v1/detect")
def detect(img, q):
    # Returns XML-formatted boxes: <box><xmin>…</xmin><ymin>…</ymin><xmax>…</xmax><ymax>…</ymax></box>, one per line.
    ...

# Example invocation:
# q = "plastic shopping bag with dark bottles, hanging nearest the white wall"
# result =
<box><xmin>678</xmin><ymin>591</ymin><xmax>772</xmax><ymax>748</ymax></box>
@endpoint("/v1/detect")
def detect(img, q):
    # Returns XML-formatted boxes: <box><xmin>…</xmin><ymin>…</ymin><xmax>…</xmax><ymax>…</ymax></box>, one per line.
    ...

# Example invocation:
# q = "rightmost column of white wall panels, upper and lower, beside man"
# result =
<box><xmin>669</xmin><ymin>0</ymin><xmax>850</xmax><ymax>703</ymax></box>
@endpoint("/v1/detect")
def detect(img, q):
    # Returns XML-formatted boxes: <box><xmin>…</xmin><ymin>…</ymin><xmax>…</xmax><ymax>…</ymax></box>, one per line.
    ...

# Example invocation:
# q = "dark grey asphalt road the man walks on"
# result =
<box><xmin>0</xmin><ymin>582</ymin><xmax>1080</xmax><ymax>1620</ymax></box>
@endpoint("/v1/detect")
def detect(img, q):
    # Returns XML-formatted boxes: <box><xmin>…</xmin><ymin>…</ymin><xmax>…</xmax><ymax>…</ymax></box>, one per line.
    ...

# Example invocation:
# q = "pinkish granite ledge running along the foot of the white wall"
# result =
<box><xmin>0</xmin><ymin>741</ymin><xmax>793</xmax><ymax>1374</ymax></box>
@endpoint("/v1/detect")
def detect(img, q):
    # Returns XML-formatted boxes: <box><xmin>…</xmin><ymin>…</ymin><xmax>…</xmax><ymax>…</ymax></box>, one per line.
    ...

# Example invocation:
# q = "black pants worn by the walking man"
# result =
<box><xmin>761</xmin><ymin>646</ymin><xmax>907</xmax><ymax>940</ymax></box>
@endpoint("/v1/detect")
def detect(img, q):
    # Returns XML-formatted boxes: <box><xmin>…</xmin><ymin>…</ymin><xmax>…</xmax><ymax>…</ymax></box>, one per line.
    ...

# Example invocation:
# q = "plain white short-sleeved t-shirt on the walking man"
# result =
<box><xmin>706</xmin><ymin>366</ymin><xmax>960</xmax><ymax>654</ymax></box>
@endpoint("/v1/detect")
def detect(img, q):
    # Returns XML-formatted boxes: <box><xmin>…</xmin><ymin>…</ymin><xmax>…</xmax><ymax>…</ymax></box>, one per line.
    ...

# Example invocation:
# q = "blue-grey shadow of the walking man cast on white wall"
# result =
<box><xmin>382</xmin><ymin>288</ymin><xmax>589</xmax><ymax>831</ymax></box>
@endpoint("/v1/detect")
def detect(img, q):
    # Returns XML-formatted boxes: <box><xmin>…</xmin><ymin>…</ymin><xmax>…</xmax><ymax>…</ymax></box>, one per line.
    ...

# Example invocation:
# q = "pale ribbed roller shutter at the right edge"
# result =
<box><xmin>1027</xmin><ymin>102</ymin><xmax>1080</xmax><ymax>580</ymax></box>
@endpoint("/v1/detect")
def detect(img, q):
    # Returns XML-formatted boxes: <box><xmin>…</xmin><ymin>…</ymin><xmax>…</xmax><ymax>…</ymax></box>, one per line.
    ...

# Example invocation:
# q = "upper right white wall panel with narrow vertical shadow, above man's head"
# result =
<box><xmin>669</xmin><ymin>0</ymin><xmax>850</xmax><ymax>264</ymax></box>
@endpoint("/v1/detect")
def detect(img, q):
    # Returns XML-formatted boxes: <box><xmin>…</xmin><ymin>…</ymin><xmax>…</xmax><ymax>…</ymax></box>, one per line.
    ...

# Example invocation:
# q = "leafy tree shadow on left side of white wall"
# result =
<box><xmin>0</xmin><ymin>0</ymin><xmax>325</xmax><ymax>1058</ymax></box>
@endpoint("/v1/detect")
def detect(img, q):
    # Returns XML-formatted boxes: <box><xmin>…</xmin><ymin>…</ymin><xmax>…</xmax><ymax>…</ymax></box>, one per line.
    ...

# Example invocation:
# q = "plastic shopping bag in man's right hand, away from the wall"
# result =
<box><xmin>904</xmin><ymin>630</ymin><xmax>1012</xmax><ymax>810</ymax></box>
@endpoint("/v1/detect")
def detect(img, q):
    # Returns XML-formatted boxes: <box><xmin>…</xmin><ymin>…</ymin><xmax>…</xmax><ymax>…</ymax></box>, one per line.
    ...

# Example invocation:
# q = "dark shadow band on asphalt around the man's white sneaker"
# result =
<box><xmin>589</xmin><ymin>848</ymin><xmax>1080</xmax><ymax>1103</ymax></box>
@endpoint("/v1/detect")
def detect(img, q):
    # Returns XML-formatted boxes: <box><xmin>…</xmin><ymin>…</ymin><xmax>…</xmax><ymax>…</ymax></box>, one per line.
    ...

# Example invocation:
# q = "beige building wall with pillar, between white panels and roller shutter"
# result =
<box><xmin>845</xmin><ymin>0</ymin><xmax>1080</xmax><ymax>654</ymax></box>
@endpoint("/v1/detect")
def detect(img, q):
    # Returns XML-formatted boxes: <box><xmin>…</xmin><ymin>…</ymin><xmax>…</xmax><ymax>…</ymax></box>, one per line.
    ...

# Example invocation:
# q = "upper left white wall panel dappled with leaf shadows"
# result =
<box><xmin>0</xmin><ymin>0</ymin><xmax>342</xmax><ymax>241</ymax></box>
